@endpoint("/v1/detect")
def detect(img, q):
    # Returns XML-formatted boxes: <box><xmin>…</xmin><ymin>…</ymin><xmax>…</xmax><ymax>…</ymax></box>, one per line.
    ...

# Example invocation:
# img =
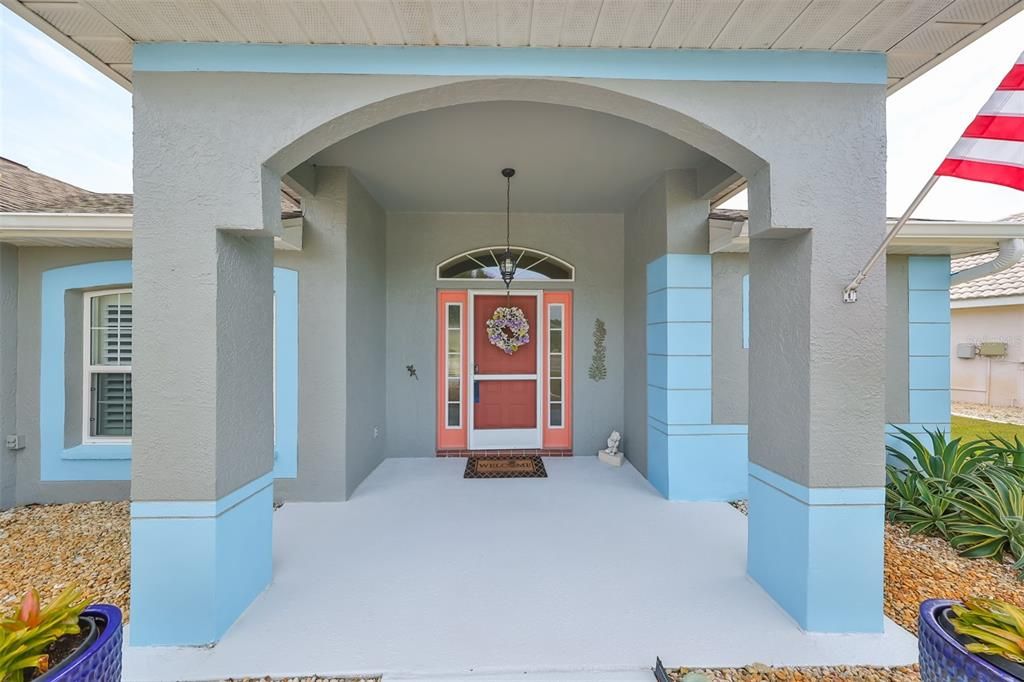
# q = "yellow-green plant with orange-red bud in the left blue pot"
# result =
<box><xmin>0</xmin><ymin>587</ymin><xmax>88</xmax><ymax>682</ymax></box>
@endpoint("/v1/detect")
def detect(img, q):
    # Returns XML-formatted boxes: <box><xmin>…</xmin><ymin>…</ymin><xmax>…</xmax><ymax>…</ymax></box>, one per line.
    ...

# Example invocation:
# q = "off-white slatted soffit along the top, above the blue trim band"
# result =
<box><xmin>2</xmin><ymin>0</ymin><xmax>1024</xmax><ymax>91</ymax></box>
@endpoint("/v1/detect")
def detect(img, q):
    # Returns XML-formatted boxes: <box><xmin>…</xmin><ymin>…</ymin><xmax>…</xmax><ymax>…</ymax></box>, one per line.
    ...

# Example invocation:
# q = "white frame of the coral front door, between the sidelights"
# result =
<box><xmin>466</xmin><ymin>289</ymin><xmax>545</xmax><ymax>450</ymax></box>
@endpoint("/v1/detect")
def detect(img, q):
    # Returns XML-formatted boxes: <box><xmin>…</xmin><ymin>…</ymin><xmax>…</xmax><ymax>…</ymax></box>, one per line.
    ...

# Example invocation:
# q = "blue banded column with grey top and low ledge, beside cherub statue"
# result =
<box><xmin>627</xmin><ymin>171</ymin><xmax>746</xmax><ymax>500</ymax></box>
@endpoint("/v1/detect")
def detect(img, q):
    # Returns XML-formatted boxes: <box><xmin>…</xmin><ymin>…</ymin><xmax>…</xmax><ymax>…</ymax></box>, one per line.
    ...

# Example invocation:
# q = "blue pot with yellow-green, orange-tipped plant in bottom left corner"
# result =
<box><xmin>0</xmin><ymin>587</ymin><xmax>121</xmax><ymax>682</ymax></box>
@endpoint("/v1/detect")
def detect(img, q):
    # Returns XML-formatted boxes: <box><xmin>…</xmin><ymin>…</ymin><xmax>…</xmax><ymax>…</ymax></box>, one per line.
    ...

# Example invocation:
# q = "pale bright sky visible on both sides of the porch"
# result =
<box><xmin>0</xmin><ymin>7</ymin><xmax>1024</xmax><ymax>220</ymax></box>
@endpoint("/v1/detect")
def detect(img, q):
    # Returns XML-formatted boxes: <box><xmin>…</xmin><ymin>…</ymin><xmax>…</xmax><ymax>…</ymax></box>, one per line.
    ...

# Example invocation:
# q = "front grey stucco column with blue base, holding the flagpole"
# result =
<box><xmin>748</xmin><ymin>114</ymin><xmax>886</xmax><ymax>632</ymax></box>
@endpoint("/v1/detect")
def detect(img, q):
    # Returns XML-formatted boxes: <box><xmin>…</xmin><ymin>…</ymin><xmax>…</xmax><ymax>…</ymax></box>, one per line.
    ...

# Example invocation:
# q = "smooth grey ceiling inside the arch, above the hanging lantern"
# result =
<box><xmin>311</xmin><ymin>101</ymin><xmax>717</xmax><ymax>213</ymax></box>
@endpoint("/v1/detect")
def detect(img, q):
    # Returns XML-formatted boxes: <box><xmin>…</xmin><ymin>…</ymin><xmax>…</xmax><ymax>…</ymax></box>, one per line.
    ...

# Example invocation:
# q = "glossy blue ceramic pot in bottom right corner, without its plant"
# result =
<box><xmin>918</xmin><ymin>599</ymin><xmax>1022</xmax><ymax>682</ymax></box>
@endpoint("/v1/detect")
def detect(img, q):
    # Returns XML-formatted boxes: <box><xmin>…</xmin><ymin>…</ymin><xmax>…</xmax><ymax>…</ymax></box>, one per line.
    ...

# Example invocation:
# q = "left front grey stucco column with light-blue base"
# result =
<box><xmin>130</xmin><ymin>78</ymin><xmax>280</xmax><ymax>645</ymax></box>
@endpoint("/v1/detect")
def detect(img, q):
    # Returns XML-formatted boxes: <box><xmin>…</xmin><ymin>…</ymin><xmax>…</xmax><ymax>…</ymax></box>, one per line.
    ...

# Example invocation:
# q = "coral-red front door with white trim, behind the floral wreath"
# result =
<box><xmin>469</xmin><ymin>293</ymin><xmax>544</xmax><ymax>450</ymax></box>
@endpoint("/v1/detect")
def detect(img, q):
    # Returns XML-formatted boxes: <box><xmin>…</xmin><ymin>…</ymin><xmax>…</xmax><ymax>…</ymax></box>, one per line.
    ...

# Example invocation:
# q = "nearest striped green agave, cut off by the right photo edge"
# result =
<box><xmin>948</xmin><ymin>466</ymin><xmax>1024</xmax><ymax>572</ymax></box>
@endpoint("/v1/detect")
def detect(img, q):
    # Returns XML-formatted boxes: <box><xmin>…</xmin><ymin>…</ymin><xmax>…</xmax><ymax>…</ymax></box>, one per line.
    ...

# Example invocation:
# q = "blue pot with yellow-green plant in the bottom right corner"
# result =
<box><xmin>918</xmin><ymin>599</ymin><xmax>1024</xmax><ymax>682</ymax></box>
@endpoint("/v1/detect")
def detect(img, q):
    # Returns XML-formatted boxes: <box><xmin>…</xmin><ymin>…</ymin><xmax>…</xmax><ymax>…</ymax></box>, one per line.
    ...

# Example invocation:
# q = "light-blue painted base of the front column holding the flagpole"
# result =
<box><xmin>746</xmin><ymin>463</ymin><xmax>885</xmax><ymax>633</ymax></box>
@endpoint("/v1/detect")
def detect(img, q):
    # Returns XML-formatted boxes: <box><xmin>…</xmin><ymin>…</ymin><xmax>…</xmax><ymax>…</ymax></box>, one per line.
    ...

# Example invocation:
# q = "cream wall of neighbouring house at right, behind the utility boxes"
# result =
<box><xmin>949</xmin><ymin>305</ymin><xmax>1024</xmax><ymax>407</ymax></box>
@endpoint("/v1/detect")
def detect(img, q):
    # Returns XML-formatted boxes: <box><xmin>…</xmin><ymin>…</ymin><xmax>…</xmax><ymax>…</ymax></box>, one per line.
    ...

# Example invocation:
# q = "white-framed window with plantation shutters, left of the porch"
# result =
<box><xmin>82</xmin><ymin>289</ymin><xmax>132</xmax><ymax>442</ymax></box>
